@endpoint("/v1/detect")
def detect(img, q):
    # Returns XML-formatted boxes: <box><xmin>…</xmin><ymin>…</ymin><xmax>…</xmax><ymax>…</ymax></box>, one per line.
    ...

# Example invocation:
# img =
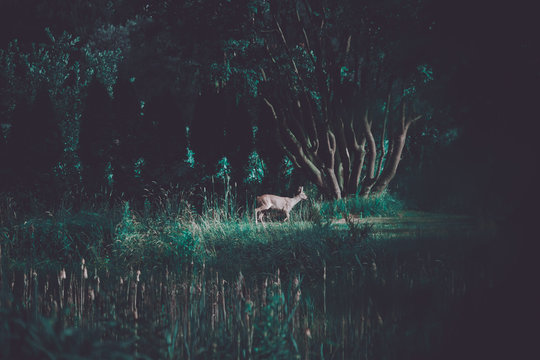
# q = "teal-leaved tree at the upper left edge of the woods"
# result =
<box><xmin>0</xmin><ymin>29</ymin><xmax>122</xmax><ymax>187</ymax></box>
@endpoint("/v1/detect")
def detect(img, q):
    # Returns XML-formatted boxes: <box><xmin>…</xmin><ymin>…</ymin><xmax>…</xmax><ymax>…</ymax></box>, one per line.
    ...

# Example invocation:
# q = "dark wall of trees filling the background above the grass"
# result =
<box><xmin>0</xmin><ymin>0</ymin><xmax>539</xmax><ymax>211</ymax></box>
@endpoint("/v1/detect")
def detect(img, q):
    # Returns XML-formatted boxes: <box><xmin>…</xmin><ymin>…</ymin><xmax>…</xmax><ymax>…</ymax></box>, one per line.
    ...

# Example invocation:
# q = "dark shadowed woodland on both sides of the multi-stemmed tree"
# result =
<box><xmin>0</xmin><ymin>0</ymin><xmax>540</xmax><ymax>358</ymax></box>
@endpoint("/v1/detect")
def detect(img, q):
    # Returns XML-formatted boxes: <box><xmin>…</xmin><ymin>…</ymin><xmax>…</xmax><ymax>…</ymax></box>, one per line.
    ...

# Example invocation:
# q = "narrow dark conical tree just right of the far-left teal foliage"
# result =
<box><xmin>78</xmin><ymin>79</ymin><xmax>113</xmax><ymax>194</ymax></box>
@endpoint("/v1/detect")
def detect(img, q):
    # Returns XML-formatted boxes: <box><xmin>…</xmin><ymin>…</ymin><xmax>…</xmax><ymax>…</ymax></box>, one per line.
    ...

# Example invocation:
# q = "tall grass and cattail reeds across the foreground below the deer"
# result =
<box><xmin>0</xmin><ymin>195</ymin><xmax>504</xmax><ymax>359</ymax></box>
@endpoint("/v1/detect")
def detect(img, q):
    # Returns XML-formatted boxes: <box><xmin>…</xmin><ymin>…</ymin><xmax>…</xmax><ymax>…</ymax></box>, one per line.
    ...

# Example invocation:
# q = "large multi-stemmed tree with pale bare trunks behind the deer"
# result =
<box><xmin>217</xmin><ymin>1</ymin><xmax>432</xmax><ymax>198</ymax></box>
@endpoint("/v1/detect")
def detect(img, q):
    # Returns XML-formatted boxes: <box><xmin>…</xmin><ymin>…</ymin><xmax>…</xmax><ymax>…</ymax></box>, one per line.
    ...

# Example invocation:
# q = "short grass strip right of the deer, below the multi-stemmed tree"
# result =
<box><xmin>334</xmin><ymin>210</ymin><xmax>484</xmax><ymax>237</ymax></box>
